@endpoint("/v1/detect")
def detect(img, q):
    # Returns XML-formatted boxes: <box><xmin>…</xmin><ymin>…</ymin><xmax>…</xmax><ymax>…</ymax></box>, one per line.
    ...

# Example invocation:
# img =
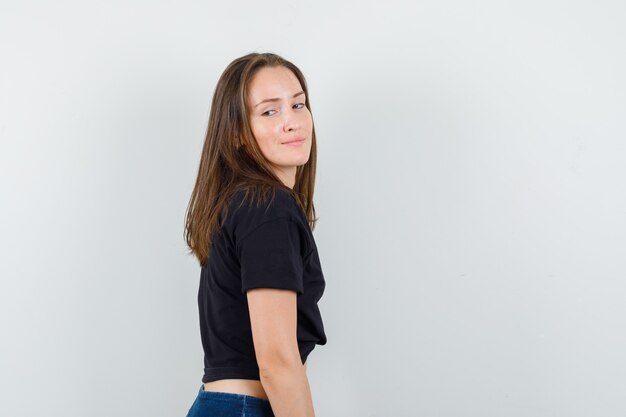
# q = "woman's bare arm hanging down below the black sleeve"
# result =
<box><xmin>246</xmin><ymin>288</ymin><xmax>315</xmax><ymax>417</ymax></box>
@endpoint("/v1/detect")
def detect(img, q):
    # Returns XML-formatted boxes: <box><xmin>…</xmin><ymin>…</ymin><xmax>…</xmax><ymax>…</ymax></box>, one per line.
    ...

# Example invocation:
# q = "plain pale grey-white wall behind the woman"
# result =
<box><xmin>0</xmin><ymin>0</ymin><xmax>626</xmax><ymax>417</ymax></box>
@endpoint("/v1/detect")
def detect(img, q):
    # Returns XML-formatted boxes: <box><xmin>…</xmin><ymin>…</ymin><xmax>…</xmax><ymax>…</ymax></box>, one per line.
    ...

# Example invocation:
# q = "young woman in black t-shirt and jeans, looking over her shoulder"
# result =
<box><xmin>185</xmin><ymin>53</ymin><xmax>326</xmax><ymax>417</ymax></box>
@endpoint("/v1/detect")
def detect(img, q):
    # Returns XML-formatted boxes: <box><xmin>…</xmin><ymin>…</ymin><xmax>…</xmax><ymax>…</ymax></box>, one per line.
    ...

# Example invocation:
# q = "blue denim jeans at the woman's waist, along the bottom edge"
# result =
<box><xmin>187</xmin><ymin>384</ymin><xmax>274</xmax><ymax>417</ymax></box>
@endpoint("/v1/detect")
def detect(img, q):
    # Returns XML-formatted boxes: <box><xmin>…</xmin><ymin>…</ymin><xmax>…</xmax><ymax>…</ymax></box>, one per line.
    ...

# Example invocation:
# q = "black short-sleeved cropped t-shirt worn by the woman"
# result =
<box><xmin>198</xmin><ymin>188</ymin><xmax>326</xmax><ymax>382</ymax></box>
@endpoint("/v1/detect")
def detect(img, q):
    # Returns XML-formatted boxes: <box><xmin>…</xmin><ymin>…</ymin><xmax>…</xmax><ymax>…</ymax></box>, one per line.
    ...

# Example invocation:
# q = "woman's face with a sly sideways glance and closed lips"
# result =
<box><xmin>247</xmin><ymin>66</ymin><xmax>313</xmax><ymax>188</ymax></box>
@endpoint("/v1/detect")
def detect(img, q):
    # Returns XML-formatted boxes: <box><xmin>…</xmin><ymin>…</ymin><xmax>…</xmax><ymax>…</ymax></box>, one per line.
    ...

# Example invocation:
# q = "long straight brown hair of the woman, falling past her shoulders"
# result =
<box><xmin>184</xmin><ymin>52</ymin><xmax>318</xmax><ymax>265</ymax></box>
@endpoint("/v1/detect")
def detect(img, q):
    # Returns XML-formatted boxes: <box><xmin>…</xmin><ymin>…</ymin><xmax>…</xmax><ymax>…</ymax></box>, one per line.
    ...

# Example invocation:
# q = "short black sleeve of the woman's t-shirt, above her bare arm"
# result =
<box><xmin>238</xmin><ymin>217</ymin><xmax>304</xmax><ymax>295</ymax></box>
